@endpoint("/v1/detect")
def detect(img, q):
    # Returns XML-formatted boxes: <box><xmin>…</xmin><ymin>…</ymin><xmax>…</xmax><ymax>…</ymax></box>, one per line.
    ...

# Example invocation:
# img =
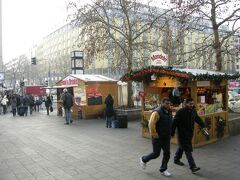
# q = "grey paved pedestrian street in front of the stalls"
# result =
<box><xmin>0</xmin><ymin>112</ymin><xmax>240</xmax><ymax>180</ymax></box>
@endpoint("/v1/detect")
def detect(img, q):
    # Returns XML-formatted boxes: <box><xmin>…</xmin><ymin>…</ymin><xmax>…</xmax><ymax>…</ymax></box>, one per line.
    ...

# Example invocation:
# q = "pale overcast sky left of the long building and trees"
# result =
<box><xmin>2</xmin><ymin>0</ymin><xmax>68</xmax><ymax>63</ymax></box>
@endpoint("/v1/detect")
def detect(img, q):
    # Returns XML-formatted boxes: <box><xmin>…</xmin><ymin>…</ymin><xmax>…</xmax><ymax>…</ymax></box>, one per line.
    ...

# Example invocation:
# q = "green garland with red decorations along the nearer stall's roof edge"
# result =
<box><xmin>120</xmin><ymin>66</ymin><xmax>240</xmax><ymax>82</ymax></box>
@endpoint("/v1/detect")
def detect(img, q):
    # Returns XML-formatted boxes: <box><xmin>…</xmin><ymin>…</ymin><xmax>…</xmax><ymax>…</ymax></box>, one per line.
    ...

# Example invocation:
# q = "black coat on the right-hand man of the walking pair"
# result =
<box><xmin>172</xmin><ymin>107</ymin><xmax>205</xmax><ymax>152</ymax></box>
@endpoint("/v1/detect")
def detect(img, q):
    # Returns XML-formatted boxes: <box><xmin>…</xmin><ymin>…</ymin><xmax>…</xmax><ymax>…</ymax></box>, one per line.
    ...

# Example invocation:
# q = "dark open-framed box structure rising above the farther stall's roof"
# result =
<box><xmin>71</xmin><ymin>51</ymin><xmax>84</xmax><ymax>74</ymax></box>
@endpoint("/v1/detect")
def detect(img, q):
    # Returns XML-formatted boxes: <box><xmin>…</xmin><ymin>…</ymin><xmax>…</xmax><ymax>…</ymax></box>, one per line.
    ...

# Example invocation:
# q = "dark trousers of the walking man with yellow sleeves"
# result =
<box><xmin>142</xmin><ymin>138</ymin><xmax>170</xmax><ymax>172</ymax></box>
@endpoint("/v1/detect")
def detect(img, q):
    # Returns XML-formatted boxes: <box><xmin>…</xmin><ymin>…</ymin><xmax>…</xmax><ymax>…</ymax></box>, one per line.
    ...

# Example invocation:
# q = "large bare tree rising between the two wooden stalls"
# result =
<box><xmin>69</xmin><ymin>0</ymin><xmax>172</xmax><ymax>107</ymax></box>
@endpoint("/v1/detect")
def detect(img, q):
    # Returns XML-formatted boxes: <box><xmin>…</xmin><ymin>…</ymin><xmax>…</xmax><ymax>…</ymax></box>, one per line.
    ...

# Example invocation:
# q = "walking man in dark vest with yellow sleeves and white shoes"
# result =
<box><xmin>140</xmin><ymin>97</ymin><xmax>172</xmax><ymax>176</ymax></box>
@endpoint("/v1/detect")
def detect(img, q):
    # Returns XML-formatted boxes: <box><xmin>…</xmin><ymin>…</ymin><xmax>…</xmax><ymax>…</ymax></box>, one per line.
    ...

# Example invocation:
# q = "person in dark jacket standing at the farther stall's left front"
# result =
<box><xmin>62</xmin><ymin>89</ymin><xmax>73</xmax><ymax>125</ymax></box>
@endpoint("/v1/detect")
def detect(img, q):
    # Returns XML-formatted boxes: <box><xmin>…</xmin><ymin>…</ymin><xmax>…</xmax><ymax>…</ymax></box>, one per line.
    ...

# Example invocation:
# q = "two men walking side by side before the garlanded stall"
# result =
<box><xmin>140</xmin><ymin>97</ymin><xmax>207</xmax><ymax>176</ymax></box>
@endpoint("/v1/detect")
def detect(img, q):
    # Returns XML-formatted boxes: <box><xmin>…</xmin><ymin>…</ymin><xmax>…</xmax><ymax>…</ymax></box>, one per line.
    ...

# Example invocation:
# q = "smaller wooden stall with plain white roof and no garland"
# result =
<box><xmin>55</xmin><ymin>74</ymin><xmax>118</xmax><ymax>119</ymax></box>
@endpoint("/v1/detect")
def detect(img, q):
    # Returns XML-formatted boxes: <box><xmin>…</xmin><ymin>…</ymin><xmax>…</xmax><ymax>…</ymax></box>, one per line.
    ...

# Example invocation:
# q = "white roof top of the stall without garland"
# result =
<box><xmin>70</xmin><ymin>74</ymin><xmax>117</xmax><ymax>82</ymax></box>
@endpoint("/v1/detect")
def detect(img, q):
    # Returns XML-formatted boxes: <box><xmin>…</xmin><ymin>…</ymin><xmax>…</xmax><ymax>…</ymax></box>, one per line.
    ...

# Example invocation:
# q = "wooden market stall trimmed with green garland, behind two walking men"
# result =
<box><xmin>121</xmin><ymin>66</ymin><xmax>239</xmax><ymax>147</ymax></box>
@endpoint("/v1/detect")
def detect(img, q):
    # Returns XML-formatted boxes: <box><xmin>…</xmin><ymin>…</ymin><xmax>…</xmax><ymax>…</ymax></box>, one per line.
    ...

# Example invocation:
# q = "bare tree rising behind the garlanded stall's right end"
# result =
<box><xmin>172</xmin><ymin>0</ymin><xmax>240</xmax><ymax>71</ymax></box>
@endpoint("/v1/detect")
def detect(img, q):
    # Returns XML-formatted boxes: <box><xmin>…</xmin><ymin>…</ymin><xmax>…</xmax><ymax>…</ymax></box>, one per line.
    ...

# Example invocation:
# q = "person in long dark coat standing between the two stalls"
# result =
<box><xmin>105</xmin><ymin>94</ymin><xmax>114</xmax><ymax>128</ymax></box>
